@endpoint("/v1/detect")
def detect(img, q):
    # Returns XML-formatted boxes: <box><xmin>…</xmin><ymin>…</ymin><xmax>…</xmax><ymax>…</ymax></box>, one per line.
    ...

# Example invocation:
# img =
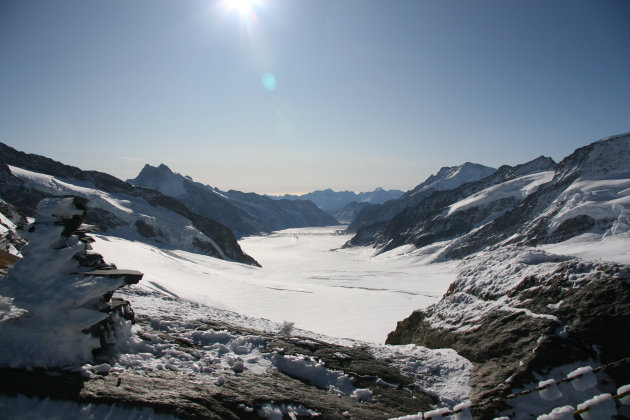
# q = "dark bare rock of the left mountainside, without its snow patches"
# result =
<box><xmin>0</xmin><ymin>143</ymin><xmax>259</xmax><ymax>265</ymax></box>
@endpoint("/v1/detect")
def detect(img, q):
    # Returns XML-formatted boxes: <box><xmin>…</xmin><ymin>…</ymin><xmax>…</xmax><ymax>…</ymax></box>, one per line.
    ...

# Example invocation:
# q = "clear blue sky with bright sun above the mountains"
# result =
<box><xmin>0</xmin><ymin>0</ymin><xmax>630</xmax><ymax>193</ymax></box>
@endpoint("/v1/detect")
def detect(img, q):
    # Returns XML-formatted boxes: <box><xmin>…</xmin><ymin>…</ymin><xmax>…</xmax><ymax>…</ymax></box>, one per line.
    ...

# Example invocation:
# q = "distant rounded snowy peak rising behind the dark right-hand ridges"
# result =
<box><xmin>404</xmin><ymin>162</ymin><xmax>497</xmax><ymax>197</ymax></box>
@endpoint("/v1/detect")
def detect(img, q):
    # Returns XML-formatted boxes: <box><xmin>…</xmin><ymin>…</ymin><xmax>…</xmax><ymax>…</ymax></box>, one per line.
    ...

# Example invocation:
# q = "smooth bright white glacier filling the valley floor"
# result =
<box><xmin>93</xmin><ymin>226</ymin><xmax>455</xmax><ymax>343</ymax></box>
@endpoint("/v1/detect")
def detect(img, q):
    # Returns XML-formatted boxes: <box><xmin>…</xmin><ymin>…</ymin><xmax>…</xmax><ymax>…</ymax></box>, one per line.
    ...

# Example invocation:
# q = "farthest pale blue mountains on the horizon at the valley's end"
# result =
<box><xmin>269</xmin><ymin>187</ymin><xmax>403</xmax><ymax>212</ymax></box>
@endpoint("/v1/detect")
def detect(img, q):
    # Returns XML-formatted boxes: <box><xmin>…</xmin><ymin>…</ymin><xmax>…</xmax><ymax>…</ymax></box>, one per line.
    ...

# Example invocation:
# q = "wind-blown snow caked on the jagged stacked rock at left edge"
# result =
<box><xmin>0</xmin><ymin>198</ymin><xmax>123</xmax><ymax>367</ymax></box>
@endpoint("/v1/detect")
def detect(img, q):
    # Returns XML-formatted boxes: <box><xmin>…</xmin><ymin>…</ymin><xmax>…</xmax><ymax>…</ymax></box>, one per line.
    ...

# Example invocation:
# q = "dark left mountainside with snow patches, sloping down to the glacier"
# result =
<box><xmin>0</xmin><ymin>143</ymin><xmax>258</xmax><ymax>265</ymax></box>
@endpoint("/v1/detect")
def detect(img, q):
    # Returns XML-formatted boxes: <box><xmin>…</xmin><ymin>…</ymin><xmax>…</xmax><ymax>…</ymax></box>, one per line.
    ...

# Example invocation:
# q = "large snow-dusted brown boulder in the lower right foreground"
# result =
<box><xmin>387</xmin><ymin>247</ymin><xmax>630</xmax><ymax>419</ymax></box>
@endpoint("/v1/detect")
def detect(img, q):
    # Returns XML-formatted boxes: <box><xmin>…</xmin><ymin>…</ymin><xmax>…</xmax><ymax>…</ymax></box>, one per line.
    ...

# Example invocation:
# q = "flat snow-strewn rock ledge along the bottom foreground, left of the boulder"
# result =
<box><xmin>0</xmin><ymin>317</ymin><xmax>436</xmax><ymax>419</ymax></box>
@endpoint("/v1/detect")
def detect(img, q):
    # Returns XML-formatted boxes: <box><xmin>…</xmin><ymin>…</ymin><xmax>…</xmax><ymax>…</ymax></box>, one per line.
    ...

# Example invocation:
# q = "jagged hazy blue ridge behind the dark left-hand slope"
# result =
<box><xmin>127</xmin><ymin>164</ymin><xmax>338</xmax><ymax>237</ymax></box>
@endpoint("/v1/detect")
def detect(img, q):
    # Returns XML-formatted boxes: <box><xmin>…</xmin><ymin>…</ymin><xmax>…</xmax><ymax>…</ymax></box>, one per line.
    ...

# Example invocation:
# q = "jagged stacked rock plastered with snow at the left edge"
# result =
<box><xmin>0</xmin><ymin>197</ymin><xmax>142</xmax><ymax>367</ymax></box>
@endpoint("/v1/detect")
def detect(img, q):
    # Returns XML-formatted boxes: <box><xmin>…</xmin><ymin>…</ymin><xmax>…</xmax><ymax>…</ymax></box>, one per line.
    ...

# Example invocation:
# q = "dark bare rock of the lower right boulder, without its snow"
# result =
<box><xmin>387</xmin><ymin>261</ymin><xmax>630</xmax><ymax>418</ymax></box>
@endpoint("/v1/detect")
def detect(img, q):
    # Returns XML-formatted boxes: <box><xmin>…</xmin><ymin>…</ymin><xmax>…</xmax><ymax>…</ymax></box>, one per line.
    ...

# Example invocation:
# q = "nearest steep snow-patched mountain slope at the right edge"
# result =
<box><xmin>444</xmin><ymin>133</ymin><xmax>630</xmax><ymax>258</ymax></box>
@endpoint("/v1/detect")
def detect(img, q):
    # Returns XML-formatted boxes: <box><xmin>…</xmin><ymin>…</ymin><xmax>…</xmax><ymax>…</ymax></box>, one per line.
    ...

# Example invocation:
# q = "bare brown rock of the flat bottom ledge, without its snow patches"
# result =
<box><xmin>0</xmin><ymin>321</ymin><xmax>435</xmax><ymax>419</ymax></box>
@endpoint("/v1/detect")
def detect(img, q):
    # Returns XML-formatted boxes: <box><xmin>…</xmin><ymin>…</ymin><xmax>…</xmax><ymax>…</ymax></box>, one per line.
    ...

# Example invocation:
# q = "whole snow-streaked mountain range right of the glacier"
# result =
<box><xmin>348</xmin><ymin>134</ymin><xmax>630</xmax><ymax>258</ymax></box>
